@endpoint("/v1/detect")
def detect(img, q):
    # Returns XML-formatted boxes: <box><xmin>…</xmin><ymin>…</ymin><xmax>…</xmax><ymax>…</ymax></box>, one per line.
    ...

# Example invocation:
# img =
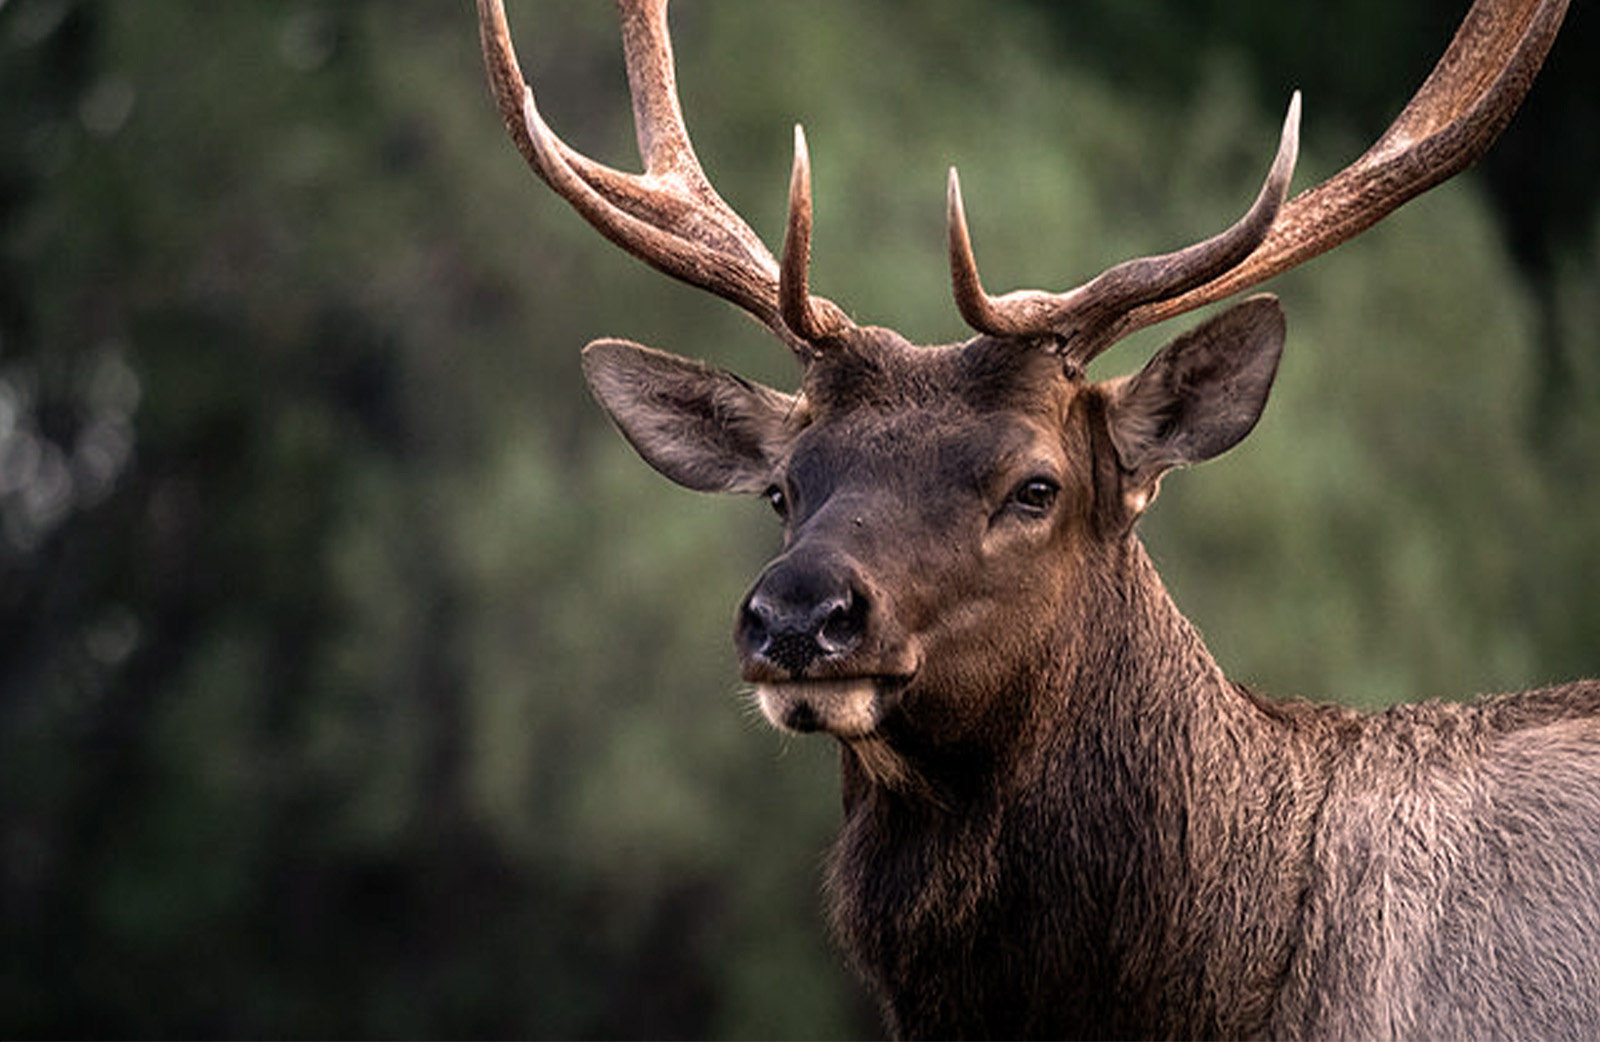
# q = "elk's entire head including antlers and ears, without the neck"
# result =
<box><xmin>478</xmin><ymin>0</ymin><xmax>1565</xmax><ymax>786</ymax></box>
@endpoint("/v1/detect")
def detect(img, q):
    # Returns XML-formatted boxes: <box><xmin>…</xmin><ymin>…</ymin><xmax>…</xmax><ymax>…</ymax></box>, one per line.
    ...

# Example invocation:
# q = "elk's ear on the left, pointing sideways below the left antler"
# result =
<box><xmin>584</xmin><ymin>339</ymin><xmax>798</xmax><ymax>493</ymax></box>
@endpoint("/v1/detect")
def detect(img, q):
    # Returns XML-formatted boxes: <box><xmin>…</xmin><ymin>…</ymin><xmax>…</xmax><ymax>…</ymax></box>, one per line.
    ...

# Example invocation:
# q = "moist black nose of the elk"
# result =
<box><xmin>738</xmin><ymin>562</ymin><xmax>867</xmax><ymax>677</ymax></box>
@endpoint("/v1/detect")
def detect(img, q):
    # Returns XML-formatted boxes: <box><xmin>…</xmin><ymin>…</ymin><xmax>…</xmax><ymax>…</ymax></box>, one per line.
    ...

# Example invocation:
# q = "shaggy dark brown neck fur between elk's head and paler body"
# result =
<box><xmin>829</xmin><ymin>535</ymin><xmax>1344</xmax><ymax>1037</ymax></box>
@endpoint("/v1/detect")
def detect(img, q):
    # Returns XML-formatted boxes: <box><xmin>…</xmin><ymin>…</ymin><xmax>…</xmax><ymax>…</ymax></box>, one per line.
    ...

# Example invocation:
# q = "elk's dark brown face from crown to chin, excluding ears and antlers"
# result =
<box><xmin>736</xmin><ymin>331</ymin><xmax>1094</xmax><ymax>765</ymax></box>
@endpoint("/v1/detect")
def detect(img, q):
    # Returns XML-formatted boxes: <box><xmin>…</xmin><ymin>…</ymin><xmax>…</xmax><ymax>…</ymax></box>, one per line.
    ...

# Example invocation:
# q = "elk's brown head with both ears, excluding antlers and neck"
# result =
<box><xmin>586</xmin><ymin>298</ymin><xmax>1283</xmax><ymax>765</ymax></box>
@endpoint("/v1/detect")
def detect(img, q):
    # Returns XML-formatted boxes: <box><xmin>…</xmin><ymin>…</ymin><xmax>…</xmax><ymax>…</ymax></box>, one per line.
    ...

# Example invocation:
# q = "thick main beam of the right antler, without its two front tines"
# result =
<box><xmin>1109</xmin><ymin>0</ymin><xmax>1568</xmax><ymax>339</ymax></box>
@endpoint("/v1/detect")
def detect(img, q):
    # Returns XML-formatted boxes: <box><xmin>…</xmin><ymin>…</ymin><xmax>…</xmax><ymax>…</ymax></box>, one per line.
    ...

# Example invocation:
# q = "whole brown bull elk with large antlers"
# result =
<box><xmin>478</xmin><ymin>0</ymin><xmax>1600</xmax><ymax>1039</ymax></box>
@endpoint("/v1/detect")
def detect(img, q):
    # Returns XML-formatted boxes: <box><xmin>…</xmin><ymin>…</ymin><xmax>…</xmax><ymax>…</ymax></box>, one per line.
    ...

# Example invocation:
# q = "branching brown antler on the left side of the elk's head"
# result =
<box><xmin>478</xmin><ymin>0</ymin><xmax>851</xmax><ymax>359</ymax></box>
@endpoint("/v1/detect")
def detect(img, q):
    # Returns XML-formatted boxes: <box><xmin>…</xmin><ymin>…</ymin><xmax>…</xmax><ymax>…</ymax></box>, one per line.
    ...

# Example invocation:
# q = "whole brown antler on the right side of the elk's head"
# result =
<box><xmin>949</xmin><ymin>0</ymin><xmax>1566</xmax><ymax>365</ymax></box>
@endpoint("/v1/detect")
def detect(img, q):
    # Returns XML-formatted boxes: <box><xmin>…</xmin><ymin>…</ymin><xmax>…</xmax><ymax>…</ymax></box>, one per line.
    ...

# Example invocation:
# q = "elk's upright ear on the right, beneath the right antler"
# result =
<box><xmin>1107</xmin><ymin>295</ymin><xmax>1285</xmax><ymax>514</ymax></box>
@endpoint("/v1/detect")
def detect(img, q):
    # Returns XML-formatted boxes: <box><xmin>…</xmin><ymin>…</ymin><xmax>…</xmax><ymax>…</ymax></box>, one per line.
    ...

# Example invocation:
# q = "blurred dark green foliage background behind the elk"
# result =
<box><xmin>0</xmin><ymin>0</ymin><xmax>1600</xmax><ymax>1039</ymax></box>
